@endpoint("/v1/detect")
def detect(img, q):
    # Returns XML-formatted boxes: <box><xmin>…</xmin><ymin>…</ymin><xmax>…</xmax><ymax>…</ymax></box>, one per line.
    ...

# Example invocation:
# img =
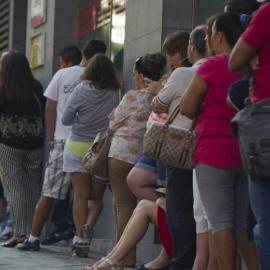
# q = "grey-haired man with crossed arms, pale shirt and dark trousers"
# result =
<box><xmin>150</xmin><ymin>25</ymin><xmax>206</xmax><ymax>270</ymax></box>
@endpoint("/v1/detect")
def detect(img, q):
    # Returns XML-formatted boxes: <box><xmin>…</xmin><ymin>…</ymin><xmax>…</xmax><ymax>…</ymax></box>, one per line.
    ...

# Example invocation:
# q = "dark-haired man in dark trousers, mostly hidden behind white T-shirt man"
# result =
<box><xmin>42</xmin><ymin>46</ymin><xmax>82</xmax><ymax>245</ymax></box>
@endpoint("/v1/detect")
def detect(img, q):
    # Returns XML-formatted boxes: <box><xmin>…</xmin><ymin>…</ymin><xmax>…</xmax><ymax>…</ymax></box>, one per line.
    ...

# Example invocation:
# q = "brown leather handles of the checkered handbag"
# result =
<box><xmin>157</xmin><ymin>105</ymin><xmax>197</xmax><ymax>150</ymax></box>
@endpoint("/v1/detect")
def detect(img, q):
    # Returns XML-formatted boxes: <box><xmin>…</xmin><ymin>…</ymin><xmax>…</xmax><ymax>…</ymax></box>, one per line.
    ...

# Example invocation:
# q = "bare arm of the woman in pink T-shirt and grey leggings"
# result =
<box><xmin>180</xmin><ymin>74</ymin><xmax>208</xmax><ymax>119</ymax></box>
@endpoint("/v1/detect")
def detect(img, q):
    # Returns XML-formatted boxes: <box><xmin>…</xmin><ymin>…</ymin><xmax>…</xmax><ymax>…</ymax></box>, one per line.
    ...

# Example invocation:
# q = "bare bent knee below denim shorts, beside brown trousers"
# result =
<box><xmin>127</xmin><ymin>167</ymin><xmax>158</xmax><ymax>202</ymax></box>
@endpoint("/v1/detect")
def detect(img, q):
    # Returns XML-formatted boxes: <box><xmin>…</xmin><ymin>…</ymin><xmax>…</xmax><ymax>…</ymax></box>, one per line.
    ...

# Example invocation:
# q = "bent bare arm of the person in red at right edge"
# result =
<box><xmin>229</xmin><ymin>38</ymin><xmax>257</xmax><ymax>75</ymax></box>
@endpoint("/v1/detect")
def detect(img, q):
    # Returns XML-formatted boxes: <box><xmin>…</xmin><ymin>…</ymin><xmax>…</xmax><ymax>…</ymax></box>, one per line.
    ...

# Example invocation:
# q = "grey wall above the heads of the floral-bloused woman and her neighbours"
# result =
<box><xmin>123</xmin><ymin>0</ymin><xmax>223</xmax><ymax>92</ymax></box>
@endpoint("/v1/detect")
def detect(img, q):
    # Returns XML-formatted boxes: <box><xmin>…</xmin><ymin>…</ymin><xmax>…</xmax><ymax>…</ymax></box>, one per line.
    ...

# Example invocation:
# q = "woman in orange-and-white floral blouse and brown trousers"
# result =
<box><xmin>109</xmin><ymin>53</ymin><xmax>166</xmax><ymax>266</ymax></box>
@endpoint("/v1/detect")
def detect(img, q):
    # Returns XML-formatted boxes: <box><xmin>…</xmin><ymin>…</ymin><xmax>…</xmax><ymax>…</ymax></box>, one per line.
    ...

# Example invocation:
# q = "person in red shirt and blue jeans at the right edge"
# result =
<box><xmin>230</xmin><ymin>1</ymin><xmax>270</xmax><ymax>270</ymax></box>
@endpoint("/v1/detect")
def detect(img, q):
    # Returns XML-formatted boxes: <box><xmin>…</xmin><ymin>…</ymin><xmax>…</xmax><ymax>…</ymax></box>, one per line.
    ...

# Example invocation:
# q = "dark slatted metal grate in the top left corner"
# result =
<box><xmin>0</xmin><ymin>0</ymin><xmax>10</xmax><ymax>53</ymax></box>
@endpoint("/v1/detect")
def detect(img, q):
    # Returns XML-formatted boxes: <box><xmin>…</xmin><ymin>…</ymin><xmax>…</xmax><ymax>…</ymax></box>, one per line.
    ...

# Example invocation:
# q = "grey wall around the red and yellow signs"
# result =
<box><xmin>26</xmin><ymin>0</ymin><xmax>77</xmax><ymax>88</ymax></box>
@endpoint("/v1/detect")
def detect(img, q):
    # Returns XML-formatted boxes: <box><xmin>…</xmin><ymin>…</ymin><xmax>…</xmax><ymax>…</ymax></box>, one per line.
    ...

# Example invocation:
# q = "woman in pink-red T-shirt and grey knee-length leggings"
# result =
<box><xmin>180</xmin><ymin>12</ymin><xmax>258</xmax><ymax>270</ymax></box>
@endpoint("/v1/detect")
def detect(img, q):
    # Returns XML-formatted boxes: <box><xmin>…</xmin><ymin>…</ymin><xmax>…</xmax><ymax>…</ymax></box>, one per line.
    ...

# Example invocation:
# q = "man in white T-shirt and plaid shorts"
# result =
<box><xmin>17</xmin><ymin>40</ymin><xmax>106</xmax><ymax>251</ymax></box>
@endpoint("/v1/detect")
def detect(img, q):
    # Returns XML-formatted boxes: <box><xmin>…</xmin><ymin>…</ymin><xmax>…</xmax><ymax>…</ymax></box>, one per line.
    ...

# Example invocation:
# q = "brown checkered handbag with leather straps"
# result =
<box><xmin>143</xmin><ymin>106</ymin><xmax>196</xmax><ymax>169</ymax></box>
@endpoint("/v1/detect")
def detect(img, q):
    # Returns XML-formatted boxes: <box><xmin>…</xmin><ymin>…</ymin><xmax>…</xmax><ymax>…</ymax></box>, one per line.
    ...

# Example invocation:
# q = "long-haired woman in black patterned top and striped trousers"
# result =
<box><xmin>0</xmin><ymin>52</ymin><xmax>45</xmax><ymax>247</ymax></box>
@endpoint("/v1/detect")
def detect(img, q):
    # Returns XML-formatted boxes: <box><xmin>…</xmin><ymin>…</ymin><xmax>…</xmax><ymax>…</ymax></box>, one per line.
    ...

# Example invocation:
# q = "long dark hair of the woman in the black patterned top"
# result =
<box><xmin>0</xmin><ymin>51</ymin><xmax>35</xmax><ymax>101</ymax></box>
